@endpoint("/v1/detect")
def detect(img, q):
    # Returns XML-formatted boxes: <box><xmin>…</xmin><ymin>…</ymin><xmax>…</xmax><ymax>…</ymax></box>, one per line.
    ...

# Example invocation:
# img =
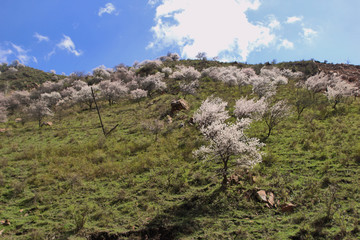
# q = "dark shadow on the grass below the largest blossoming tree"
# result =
<box><xmin>88</xmin><ymin>188</ymin><xmax>231</xmax><ymax>240</ymax></box>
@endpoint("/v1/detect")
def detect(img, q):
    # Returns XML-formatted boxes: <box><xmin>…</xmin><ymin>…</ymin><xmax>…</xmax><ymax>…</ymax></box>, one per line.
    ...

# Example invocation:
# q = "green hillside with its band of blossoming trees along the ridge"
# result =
<box><xmin>0</xmin><ymin>60</ymin><xmax>360</xmax><ymax>239</ymax></box>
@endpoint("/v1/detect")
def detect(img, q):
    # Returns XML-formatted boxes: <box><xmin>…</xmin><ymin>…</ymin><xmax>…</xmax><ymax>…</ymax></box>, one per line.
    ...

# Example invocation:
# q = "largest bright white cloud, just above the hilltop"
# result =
<box><xmin>148</xmin><ymin>0</ymin><xmax>276</xmax><ymax>61</ymax></box>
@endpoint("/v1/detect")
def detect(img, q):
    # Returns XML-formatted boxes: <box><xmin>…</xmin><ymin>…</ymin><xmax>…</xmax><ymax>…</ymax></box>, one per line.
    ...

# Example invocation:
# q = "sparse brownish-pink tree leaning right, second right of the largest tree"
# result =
<box><xmin>263</xmin><ymin>100</ymin><xmax>290</xmax><ymax>140</ymax></box>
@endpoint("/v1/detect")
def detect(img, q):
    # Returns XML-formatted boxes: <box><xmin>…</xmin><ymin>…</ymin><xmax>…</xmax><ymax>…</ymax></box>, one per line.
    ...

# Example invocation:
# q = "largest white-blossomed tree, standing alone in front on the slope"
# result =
<box><xmin>194</xmin><ymin>99</ymin><xmax>263</xmax><ymax>187</ymax></box>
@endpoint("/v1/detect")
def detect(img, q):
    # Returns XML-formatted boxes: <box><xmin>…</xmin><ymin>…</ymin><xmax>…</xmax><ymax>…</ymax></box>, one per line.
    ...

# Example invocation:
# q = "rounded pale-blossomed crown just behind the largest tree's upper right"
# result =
<box><xmin>234</xmin><ymin>97</ymin><xmax>267</xmax><ymax>120</ymax></box>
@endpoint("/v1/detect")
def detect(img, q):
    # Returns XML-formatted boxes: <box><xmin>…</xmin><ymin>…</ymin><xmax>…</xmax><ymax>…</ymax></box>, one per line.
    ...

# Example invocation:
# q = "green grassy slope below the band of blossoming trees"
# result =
<box><xmin>0</xmin><ymin>62</ymin><xmax>360</xmax><ymax>239</ymax></box>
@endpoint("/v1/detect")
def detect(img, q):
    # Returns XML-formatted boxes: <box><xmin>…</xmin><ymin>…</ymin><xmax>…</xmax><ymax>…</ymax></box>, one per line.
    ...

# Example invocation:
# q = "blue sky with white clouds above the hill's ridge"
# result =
<box><xmin>0</xmin><ymin>0</ymin><xmax>360</xmax><ymax>74</ymax></box>
